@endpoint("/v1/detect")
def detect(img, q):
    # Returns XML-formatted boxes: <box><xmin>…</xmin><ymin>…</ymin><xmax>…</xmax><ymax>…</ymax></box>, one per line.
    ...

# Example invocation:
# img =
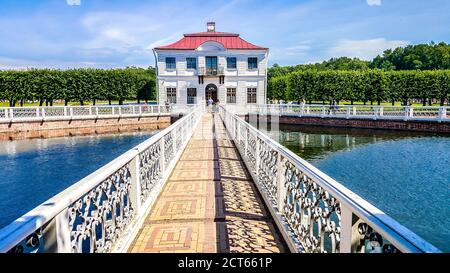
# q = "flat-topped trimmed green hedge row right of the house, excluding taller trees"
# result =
<box><xmin>268</xmin><ymin>70</ymin><xmax>450</xmax><ymax>105</ymax></box>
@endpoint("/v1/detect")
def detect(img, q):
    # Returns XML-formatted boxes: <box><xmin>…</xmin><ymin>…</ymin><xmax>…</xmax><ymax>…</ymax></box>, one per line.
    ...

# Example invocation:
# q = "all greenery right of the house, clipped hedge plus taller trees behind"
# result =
<box><xmin>268</xmin><ymin>42</ymin><xmax>450</xmax><ymax>105</ymax></box>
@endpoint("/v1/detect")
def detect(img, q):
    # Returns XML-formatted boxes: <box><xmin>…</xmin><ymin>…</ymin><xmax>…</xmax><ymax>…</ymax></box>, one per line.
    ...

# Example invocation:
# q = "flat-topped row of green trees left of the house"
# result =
<box><xmin>0</xmin><ymin>67</ymin><xmax>156</xmax><ymax>106</ymax></box>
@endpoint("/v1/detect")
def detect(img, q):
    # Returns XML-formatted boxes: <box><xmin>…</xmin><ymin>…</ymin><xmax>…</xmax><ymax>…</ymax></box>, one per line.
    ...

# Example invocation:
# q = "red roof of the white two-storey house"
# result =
<box><xmin>155</xmin><ymin>31</ymin><xmax>267</xmax><ymax>50</ymax></box>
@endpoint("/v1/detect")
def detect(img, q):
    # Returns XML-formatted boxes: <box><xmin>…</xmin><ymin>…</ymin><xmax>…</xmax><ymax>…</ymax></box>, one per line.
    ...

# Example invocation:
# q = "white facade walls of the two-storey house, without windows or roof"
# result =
<box><xmin>154</xmin><ymin>25</ymin><xmax>268</xmax><ymax>105</ymax></box>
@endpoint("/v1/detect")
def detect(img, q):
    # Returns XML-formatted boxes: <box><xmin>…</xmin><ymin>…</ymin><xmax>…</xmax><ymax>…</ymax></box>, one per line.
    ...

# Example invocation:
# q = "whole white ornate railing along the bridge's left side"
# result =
<box><xmin>0</xmin><ymin>103</ymin><xmax>202</xmax><ymax>252</ymax></box>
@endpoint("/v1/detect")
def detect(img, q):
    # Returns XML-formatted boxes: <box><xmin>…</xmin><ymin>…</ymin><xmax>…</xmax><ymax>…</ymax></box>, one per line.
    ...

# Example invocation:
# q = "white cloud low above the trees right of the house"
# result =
<box><xmin>328</xmin><ymin>38</ymin><xmax>409</xmax><ymax>60</ymax></box>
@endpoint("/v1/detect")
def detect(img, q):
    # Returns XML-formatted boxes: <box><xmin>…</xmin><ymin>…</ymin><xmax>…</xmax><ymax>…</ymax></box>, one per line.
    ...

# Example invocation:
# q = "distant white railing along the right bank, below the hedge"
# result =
<box><xmin>230</xmin><ymin>104</ymin><xmax>450</xmax><ymax>122</ymax></box>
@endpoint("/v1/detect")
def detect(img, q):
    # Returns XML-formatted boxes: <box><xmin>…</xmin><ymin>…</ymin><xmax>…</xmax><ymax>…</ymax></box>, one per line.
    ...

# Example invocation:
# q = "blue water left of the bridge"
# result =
<box><xmin>0</xmin><ymin>132</ymin><xmax>155</xmax><ymax>228</ymax></box>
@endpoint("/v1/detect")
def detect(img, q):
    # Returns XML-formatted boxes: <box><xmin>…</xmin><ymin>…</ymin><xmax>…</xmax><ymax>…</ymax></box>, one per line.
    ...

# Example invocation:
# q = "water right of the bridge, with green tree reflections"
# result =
<box><xmin>260</xmin><ymin>123</ymin><xmax>450</xmax><ymax>252</ymax></box>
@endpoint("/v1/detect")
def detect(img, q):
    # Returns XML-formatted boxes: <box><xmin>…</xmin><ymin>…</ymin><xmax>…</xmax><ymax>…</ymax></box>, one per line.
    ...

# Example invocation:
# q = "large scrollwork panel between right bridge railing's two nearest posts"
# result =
<box><xmin>283</xmin><ymin>161</ymin><xmax>341</xmax><ymax>253</ymax></box>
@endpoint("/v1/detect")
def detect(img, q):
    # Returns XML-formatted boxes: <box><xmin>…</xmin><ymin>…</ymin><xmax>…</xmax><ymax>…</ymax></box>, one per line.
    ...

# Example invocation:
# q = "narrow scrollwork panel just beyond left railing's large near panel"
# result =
<box><xmin>139</xmin><ymin>141</ymin><xmax>162</xmax><ymax>202</ymax></box>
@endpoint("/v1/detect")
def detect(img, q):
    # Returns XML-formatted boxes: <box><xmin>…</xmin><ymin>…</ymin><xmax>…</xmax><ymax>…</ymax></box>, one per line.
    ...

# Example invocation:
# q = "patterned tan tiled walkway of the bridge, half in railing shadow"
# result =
<box><xmin>129</xmin><ymin>113</ymin><xmax>286</xmax><ymax>252</ymax></box>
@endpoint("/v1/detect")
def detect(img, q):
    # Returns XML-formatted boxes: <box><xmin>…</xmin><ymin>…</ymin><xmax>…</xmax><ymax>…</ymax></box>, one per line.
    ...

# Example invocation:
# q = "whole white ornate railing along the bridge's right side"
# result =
<box><xmin>219</xmin><ymin>106</ymin><xmax>439</xmax><ymax>252</ymax></box>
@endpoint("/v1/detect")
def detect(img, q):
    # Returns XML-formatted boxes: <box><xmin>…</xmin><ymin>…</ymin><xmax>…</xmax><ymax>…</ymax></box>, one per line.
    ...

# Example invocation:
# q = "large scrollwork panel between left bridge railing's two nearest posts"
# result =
<box><xmin>69</xmin><ymin>163</ymin><xmax>134</xmax><ymax>253</ymax></box>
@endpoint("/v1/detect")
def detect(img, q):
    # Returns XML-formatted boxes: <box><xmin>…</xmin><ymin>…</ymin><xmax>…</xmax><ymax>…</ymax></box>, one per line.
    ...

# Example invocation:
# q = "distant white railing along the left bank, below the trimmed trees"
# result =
<box><xmin>0</xmin><ymin>104</ymin><xmax>171</xmax><ymax>122</ymax></box>
